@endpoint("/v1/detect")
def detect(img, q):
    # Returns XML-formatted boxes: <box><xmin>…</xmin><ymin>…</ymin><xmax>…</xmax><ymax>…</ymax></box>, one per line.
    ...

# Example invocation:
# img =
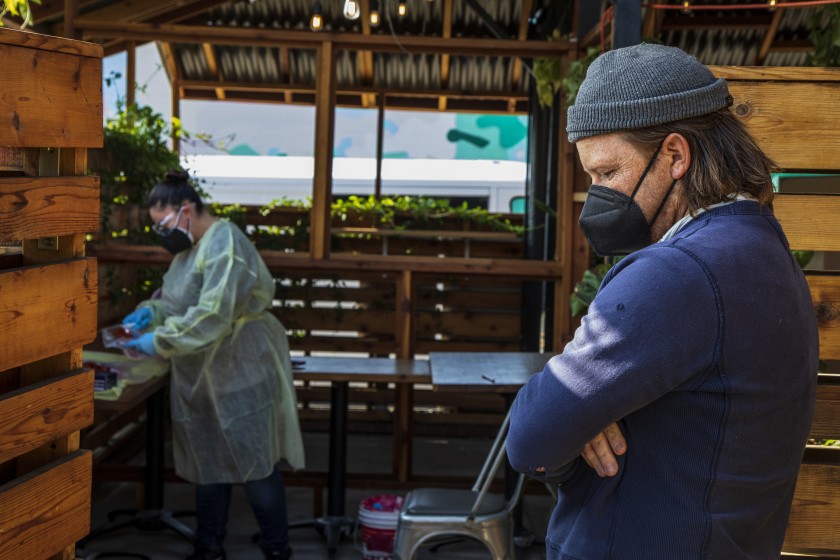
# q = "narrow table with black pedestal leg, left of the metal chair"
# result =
<box><xmin>289</xmin><ymin>357</ymin><xmax>431</xmax><ymax>558</ymax></box>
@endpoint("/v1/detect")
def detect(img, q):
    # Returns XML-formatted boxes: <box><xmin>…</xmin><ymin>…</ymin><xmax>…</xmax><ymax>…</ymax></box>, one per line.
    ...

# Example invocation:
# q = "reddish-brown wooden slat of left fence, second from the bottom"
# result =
<box><xmin>0</xmin><ymin>370</ymin><xmax>93</xmax><ymax>462</ymax></box>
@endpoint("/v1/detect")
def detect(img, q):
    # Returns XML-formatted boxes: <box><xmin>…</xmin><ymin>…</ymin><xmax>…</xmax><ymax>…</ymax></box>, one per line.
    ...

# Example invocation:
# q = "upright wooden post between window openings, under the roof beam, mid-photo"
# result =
<box><xmin>309</xmin><ymin>41</ymin><xmax>335</xmax><ymax>259</ymax></box>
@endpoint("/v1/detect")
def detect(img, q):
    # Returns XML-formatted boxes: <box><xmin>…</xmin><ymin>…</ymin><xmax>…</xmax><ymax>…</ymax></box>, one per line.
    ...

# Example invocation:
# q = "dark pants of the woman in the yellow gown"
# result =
<box><xmin>195</xmin><ymin>469</ymin><xmax>289</xmax><ymax>551</ymax></box>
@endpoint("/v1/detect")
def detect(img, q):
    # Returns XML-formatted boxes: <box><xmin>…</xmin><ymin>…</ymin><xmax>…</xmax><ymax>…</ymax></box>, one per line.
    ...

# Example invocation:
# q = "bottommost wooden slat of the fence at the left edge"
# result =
<box><xmin>0</xmin><ymin>451</ymin><xmax>92</xmax><ymax>560</ymax></box>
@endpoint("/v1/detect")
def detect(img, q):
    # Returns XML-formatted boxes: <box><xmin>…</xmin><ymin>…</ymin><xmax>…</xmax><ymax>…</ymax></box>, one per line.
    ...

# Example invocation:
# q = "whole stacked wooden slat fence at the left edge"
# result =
<box><xmin>0</xmin><ymin>29</ymin><xmax>102</xmax><ymax>560</ymax></box>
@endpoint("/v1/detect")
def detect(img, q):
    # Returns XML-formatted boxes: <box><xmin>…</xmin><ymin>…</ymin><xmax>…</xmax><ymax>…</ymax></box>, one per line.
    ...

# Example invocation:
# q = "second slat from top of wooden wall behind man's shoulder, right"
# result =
<box><xmin>773</xmin><ymin>195</ymin><xmax>840</xmax><ymax>251</ymax></box>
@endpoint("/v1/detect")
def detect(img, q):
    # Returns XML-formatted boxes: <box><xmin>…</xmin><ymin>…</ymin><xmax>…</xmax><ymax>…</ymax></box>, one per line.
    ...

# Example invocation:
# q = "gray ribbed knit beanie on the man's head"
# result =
<box><xmin>566</xmin><ymin>43</ymin><xmax>732</xmax><ymax>142</ymax></box>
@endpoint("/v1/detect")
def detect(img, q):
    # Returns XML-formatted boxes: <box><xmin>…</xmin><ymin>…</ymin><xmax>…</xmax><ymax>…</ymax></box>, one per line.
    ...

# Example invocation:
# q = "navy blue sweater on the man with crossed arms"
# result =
<box><xmin>507</xmin><ymin>201</ymin><xmax>818</xmax><ymax>560</ymax></box>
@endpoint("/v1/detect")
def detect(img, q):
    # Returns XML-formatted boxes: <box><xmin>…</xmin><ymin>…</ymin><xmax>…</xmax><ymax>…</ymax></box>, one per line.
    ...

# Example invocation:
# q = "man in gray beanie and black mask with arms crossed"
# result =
<box><xmin>507</xmin><ymin>44</ymin><xmax>818</xmax><ymax>560</ymax></box>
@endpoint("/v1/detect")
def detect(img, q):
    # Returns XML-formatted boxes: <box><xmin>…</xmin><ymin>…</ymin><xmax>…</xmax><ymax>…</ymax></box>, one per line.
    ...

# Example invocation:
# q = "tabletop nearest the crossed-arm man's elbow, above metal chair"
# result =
<box><xmin>429</xmin><ymin>352</ymin><xmax>554</xmax><ymax>393</ymax></box>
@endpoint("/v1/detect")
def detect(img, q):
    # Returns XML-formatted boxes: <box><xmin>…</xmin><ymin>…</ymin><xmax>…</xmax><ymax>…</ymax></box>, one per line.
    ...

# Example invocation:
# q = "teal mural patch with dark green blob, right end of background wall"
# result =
<box><xmin>446</xmin><ymin>114</ymin><xmax>528</xmax><ymax>161</ymax></box>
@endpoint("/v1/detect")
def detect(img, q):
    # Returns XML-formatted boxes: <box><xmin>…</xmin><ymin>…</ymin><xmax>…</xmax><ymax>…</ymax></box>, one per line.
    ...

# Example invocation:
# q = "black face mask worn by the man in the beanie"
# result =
<box><xmin>578</xmin><ymin>144</ymin><xmax>677</xmax><ymax>257</ymax></box>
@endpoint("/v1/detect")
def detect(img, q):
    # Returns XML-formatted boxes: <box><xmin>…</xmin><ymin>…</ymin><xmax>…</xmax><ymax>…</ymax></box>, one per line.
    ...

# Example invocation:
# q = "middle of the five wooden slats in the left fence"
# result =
<box><xmin>0</xmin><ymin>259</ymin><xmax>97</xmax><ymax>371</ymax></box>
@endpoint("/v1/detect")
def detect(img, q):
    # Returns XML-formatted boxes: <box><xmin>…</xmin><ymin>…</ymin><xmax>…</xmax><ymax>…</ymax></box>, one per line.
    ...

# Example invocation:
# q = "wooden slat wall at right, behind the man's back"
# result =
<box><xmin>713</xmin><ymin>67</ymin><xmax>840</xmax><ymax>555</ymax></box>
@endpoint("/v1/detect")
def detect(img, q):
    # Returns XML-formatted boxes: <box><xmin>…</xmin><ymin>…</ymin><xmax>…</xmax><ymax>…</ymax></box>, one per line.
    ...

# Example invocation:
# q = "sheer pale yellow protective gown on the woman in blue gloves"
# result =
<box><xmin>141</xmin><ymin>220</ymin><xmax>303</xmax><ymax>484</ymax></box>
